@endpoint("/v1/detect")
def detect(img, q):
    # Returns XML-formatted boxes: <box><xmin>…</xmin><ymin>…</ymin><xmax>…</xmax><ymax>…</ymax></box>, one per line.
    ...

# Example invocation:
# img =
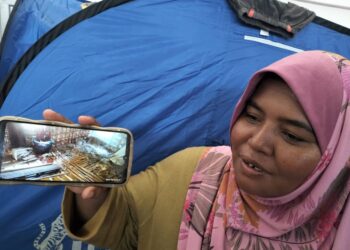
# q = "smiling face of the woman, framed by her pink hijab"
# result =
<box><xmin>231</xmin><ymin>78</ymin><xmax>321</xmax><ymax>197</ymax></box>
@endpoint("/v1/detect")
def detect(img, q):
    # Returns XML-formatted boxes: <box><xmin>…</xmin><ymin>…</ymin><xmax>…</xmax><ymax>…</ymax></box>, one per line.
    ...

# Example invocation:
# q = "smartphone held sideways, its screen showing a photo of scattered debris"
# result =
<box><xmin>0</xmin><ymin>116</ymin><xmax>133</xmax><ymax>187</ymax></box>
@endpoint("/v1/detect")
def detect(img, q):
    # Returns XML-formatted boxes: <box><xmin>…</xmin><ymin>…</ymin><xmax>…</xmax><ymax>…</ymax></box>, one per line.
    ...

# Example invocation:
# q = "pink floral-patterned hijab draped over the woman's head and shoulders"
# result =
<box><xmin>178</xmin><ymin>51</ymin><xmax>350</xmax><ymax>250</ymax></box>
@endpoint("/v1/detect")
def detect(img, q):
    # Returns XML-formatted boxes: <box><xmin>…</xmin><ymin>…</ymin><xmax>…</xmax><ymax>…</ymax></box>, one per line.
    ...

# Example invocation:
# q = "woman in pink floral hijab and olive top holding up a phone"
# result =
<box><xmin>44</xmin><ymin>51</ymin><xmax>350</xmax><ymax>250</ymax></box>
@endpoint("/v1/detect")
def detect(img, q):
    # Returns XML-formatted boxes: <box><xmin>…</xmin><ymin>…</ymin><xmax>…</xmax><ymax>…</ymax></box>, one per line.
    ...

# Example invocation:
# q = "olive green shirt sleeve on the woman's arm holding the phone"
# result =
<box><xmin>62</xmin><ymin>147</ymin><xmax>205</xmax><ymax>250</ymax></box>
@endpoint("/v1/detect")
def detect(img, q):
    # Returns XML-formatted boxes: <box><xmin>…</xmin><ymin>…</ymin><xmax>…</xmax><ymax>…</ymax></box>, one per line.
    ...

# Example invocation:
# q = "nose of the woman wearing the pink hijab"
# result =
<box><xmin>248</xmin><ymin>125</ymin><xmax>274</xmax><ymax>155</ymax></box>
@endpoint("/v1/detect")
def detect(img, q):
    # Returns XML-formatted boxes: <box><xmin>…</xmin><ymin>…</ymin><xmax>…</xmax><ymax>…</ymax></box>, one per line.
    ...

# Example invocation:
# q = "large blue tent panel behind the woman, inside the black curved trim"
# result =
<box><xmin>0</xmin><ymin>0</ymin><xmax>350</xmax><ymax>250</ymax></box>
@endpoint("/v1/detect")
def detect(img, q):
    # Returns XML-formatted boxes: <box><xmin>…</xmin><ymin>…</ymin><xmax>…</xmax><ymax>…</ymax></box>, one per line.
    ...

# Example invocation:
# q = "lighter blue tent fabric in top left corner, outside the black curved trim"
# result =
<box><xmin>0</xmin><ymin>0</ymin><xmax>81</xmax><ymax>83</ymax></box>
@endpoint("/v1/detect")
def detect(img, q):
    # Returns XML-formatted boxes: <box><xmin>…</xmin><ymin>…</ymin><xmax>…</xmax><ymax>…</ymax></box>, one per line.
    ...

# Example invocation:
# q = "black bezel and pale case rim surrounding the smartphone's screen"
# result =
<box><xmin>0</xmin><ymin>117</ymin><xmax>133</xmax><ymax>186</ymax></box>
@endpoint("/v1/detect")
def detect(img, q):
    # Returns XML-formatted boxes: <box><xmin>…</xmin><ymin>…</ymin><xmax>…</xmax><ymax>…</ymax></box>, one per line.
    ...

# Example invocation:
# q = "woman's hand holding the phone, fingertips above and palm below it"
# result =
<box><xmin>43</xmin><ymin>109</ymin><xmax>109</xmax><ymax>225</ymax></box>
